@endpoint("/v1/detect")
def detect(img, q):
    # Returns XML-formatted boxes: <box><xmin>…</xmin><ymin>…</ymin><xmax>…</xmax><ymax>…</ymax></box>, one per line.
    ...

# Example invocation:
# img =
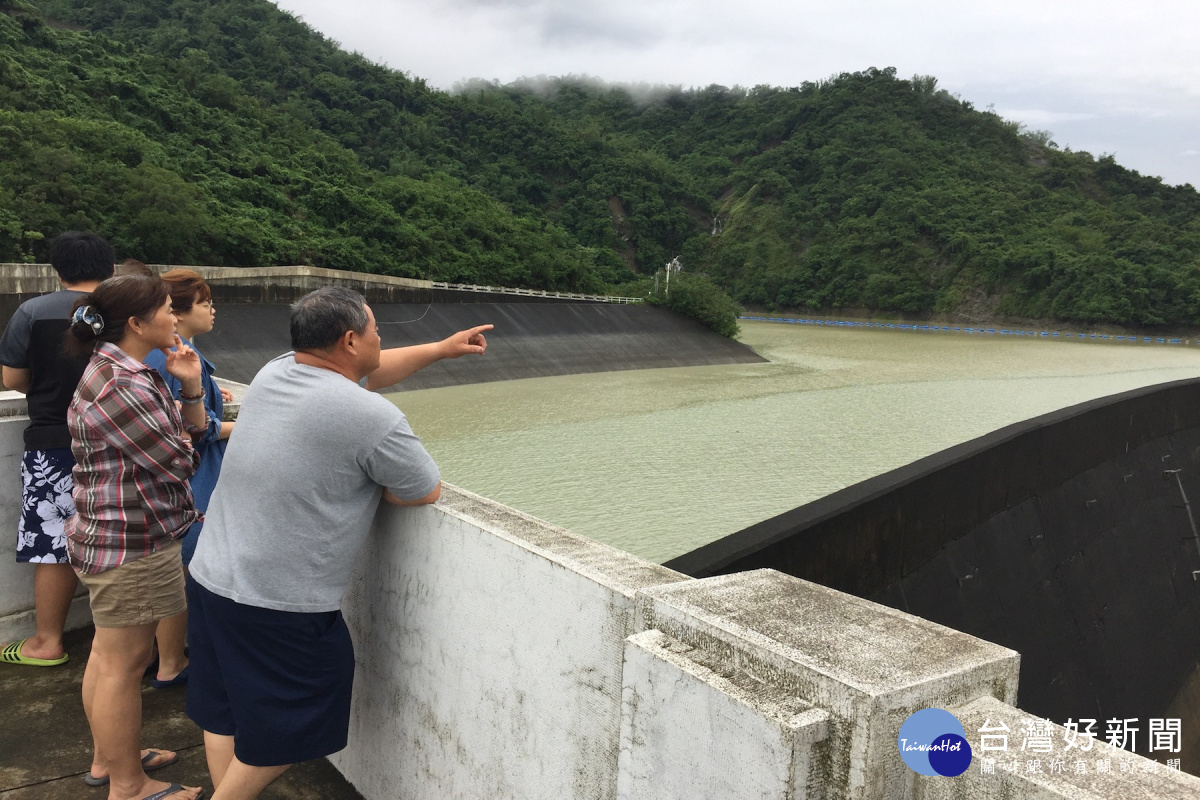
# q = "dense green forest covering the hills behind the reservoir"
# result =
<box><xmin>0</xmin><ymin>0</ymin><xmax>1200</xmax><ymax>329</ymax></box>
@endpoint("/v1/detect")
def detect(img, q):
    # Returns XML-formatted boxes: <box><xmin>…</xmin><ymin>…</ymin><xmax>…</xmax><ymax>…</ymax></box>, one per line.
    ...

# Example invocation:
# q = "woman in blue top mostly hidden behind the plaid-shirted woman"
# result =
<box><xmin>146</xmin><ymin>269</ymin><xmax>234</xmax><ymax>688</ymax></box>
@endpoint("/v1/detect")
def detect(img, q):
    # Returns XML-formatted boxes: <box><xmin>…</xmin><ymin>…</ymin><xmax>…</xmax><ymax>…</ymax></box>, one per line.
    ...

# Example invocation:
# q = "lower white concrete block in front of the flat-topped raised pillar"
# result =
<box><xmin>617</xmin><ymin>631</ymin><xmax>829</xmax><ymax>800</ymax></box>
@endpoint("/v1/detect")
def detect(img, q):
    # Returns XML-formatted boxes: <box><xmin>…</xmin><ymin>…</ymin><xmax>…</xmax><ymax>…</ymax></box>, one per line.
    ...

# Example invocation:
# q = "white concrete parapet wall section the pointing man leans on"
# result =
<box><xmin>332</xmin><ymin>486</ymin><xmax>684</xmax><ymax>800</ymax></box>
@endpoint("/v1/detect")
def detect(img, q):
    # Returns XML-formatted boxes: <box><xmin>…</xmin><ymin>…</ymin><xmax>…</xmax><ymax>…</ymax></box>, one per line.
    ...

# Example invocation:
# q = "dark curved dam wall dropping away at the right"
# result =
<box><xmin>666</xmin><ymin>379</ymin><xmax>1200</xmax><ymax>771</ymax></box>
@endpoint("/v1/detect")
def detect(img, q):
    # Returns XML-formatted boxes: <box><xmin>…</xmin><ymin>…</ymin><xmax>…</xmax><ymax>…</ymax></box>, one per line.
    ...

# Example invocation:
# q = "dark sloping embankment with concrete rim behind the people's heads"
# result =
<box><xmin>0</xmin><ymin>264</ymin><xmax>764</xmax><ymax>390</ymax></box>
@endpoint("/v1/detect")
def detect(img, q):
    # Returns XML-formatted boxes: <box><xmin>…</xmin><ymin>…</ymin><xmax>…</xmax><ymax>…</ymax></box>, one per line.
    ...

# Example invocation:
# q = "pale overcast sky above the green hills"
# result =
<box><xmin>278</xmin><ymin>0</ymin><xmax>1200</xmax><ymax>187</ymax></box>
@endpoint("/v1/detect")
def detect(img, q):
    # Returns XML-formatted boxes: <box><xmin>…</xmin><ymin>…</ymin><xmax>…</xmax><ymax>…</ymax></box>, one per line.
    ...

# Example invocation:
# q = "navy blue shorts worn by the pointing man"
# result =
<box><xmin>186</xmin><ymin>577</ymin><xmax>354</xmax><ymax>766</ymax></box>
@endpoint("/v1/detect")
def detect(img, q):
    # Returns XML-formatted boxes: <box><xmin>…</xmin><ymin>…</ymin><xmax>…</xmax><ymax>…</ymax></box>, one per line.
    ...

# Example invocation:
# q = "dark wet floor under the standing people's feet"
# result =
<box><xmin>0</xmin><ymin>627</ymin><xmax>362</xmax><ymax>800</ymax></box>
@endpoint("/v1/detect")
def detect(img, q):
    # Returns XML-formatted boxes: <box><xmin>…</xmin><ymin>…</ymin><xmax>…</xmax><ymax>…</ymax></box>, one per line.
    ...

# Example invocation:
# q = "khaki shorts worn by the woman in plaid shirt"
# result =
<box><xmin>78</xmin><ymin>541</ymin><xmax>187</xmax><ymax>627</ymax></box>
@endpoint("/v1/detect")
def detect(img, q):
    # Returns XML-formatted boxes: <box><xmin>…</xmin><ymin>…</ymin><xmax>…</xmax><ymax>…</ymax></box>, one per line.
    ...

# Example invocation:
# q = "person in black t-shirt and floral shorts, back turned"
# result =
<box><xmin>0</xmin><ymin>230</ymin><xmax>114</xmax><ymax>667</ymax></box>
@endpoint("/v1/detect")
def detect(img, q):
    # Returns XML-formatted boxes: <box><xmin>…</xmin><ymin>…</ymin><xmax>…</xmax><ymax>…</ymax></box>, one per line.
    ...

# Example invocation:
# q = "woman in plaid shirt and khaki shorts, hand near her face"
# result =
<box><xmin>66</xmin><ymin>275</ymin><xmax>206</xmax><ymax>800</ymax></box>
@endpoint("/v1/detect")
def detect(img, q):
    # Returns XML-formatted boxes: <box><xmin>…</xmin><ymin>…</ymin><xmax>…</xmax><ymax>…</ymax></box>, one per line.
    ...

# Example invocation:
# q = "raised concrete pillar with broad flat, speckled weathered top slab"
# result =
<box><xmin>637</xmin><ymin>570</ymin><xmax>1020</xmax><ymax>800</ymax></box>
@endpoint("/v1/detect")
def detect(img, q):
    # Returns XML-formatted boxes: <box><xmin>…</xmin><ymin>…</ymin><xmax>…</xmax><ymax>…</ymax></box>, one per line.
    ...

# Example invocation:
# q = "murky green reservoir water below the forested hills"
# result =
<box><xmin>391</xmin><ymin>321</ymin><xmax>1200</xmax><ymax>561</ymax></box>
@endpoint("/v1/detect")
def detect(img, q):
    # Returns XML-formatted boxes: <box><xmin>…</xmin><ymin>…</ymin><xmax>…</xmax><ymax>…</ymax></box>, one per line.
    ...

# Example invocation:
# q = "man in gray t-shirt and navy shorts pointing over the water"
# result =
<box><xmin>187</xmin><ymin>287</ymin><xmax>492</xmax><ymax>800</ymax></box>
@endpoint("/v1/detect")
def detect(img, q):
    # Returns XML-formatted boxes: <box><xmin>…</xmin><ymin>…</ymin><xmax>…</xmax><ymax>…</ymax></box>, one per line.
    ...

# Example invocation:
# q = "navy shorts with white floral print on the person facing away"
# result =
<box><xmin>17</xmin><ymin>447</ymin><xmax>74</xmax><ymax>564</ymax></box>
